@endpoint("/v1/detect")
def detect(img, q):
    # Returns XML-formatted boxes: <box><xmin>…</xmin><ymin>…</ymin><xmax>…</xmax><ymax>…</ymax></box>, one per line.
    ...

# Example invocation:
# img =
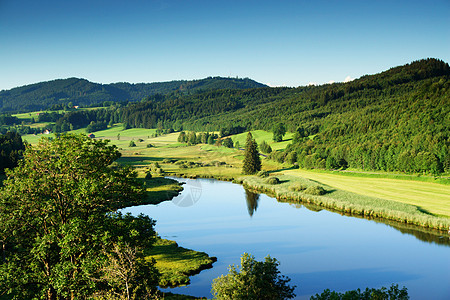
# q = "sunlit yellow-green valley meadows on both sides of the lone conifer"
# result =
<box><xmin>22</xmin><ymin>125</ymin><xmax>450</xmax><ymax>229</ymax></box>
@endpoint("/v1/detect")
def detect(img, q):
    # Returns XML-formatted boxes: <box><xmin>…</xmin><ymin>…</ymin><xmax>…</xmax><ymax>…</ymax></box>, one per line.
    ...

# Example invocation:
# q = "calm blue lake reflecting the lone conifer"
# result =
<box><xmin>124</xmin><ymin>178</ymin><xmax>450</xmax><ymax>300</ymax></box>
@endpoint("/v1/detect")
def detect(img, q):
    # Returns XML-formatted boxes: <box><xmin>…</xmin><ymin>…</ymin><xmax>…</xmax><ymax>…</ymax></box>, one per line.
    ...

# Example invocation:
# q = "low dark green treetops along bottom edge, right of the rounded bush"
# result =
<box><xmin>310</xmin><ymin>284</ymin><xmax>409</xmax><ymax>300</ymax></box>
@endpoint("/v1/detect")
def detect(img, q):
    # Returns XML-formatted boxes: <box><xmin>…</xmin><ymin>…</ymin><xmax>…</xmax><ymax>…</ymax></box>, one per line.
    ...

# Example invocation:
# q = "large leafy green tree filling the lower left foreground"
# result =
<box><xmin>0</xmin><ymin>135</ymin><xmax>158</xmax><ymax>299</ymax></box>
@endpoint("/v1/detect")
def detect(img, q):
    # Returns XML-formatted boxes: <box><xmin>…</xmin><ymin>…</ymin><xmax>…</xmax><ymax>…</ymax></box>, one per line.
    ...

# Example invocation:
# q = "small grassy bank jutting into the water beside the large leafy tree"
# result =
<box><xmin>146</xmin><ymin>238</ymin><xmax>217</xmax><ymax>287</ymax></box>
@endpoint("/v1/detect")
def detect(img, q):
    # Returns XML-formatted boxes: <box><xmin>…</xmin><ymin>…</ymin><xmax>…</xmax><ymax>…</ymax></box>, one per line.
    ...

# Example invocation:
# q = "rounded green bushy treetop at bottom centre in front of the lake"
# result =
<box><xmin>212</xmin><ymin>253</ymin><xmax>295</xmax><ymax>300</ymax></box>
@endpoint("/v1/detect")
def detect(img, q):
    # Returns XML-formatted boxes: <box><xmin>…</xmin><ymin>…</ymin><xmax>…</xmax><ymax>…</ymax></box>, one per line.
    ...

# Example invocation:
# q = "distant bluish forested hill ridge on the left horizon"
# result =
<box><xmin>0</xmin><ymin>77</ymin><xmax>265</xmax><ymax>112</ymax></box>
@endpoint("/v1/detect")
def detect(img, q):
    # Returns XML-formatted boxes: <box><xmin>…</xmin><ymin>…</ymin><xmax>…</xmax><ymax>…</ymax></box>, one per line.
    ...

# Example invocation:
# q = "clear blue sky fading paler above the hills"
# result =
<box><xmin>0</xmin><ymin>0</ymin><xmax>450</xmax><ymax>90</ymax></box>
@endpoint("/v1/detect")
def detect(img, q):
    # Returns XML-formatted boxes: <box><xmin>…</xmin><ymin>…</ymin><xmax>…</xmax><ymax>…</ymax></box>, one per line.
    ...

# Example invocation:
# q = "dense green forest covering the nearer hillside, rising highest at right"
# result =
<box><xmin>0</xmin><ymin>59</ymin><xmax>450</xmax><ymax>174</ymax></box>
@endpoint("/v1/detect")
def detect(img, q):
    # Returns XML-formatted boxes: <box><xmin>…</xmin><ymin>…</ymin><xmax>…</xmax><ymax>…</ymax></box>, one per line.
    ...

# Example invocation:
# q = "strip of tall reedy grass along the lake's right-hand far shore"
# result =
<box><xmin>242</xmin><ymin>174</ymin><xmax>450</xmax><ymax>231</ymax></box>
